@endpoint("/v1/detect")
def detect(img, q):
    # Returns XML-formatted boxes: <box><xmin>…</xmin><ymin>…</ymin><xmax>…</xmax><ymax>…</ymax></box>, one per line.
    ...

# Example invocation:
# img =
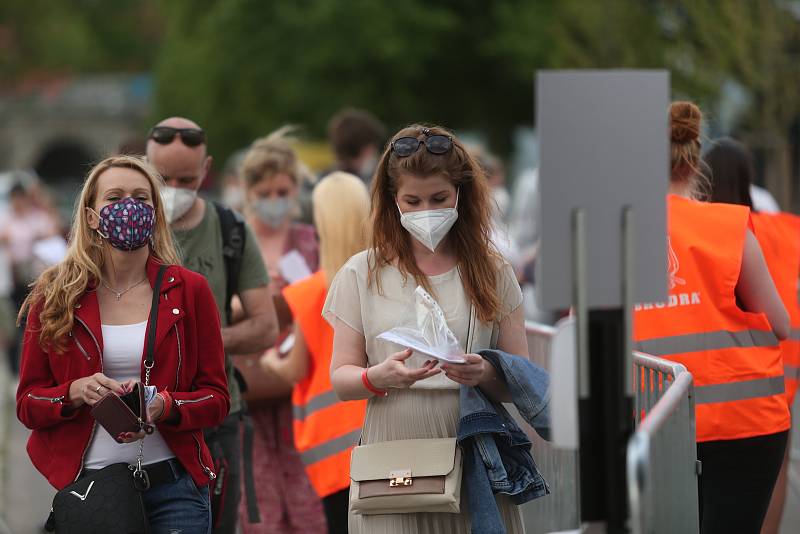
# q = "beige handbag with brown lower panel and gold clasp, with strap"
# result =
<box><xmin>350</xmin><ymin>307</ymin><xmax>476</xmax><ymax>515</ymax></box>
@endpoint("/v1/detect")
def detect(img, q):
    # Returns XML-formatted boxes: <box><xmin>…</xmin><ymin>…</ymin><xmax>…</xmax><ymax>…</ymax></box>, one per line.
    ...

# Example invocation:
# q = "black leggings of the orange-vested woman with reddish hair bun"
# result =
<box><xmin>697</xmin><ymin>431</ymin><xmax>789</xmax><ymax>534</ymax></box>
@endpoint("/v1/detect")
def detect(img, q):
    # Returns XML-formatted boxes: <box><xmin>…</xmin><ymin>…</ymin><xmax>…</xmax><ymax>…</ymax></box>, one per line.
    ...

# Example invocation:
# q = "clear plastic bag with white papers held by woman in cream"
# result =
<box><xmin>378</xmin><ymin>286</ymin><xmax>466</xmax><ymax>363</ymax></box>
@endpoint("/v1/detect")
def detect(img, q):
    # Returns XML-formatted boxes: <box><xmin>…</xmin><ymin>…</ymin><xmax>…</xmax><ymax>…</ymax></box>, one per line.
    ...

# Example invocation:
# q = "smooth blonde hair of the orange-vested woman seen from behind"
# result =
<box><xmin>311</xmin><ymin>171</ymin><xmax>369</xmax><ymax>285</ymax></box>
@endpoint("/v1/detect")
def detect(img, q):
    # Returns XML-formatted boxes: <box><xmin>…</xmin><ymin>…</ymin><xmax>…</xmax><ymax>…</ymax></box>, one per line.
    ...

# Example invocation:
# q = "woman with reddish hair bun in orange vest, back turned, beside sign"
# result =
<box><xmin>634</xmin><ymin>102</ymin><xmax>790</xmax><ymax>534</ymax></box>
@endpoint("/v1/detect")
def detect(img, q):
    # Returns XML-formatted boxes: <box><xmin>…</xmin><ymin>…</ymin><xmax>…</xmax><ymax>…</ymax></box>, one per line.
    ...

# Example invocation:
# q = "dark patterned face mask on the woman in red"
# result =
<box><xmin>97</xmin><ymin>197</ymin><xmax>155</xmax><ymax>250</ymax></box>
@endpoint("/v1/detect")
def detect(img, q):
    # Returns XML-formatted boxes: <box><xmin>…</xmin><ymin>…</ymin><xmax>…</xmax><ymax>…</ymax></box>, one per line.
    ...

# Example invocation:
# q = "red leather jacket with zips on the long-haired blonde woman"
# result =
<box><xmin>17</xmin><ymin>257</ymin><xmax>230</xmax><ymax>489</ymax></box>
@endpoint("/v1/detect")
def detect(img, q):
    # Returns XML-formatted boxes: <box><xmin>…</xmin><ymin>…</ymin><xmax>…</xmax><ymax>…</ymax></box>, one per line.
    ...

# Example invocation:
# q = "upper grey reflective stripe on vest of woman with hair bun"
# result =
<box><xmin>634</xmin><ymin>330</ymin><xmax>778</xmax><ymax>356</ymax></box>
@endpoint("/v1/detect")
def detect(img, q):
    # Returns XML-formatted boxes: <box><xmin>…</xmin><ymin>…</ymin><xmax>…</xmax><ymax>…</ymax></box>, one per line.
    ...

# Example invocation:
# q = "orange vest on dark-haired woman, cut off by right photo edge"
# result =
<box><xmin>753</xmin><ymin>213</ymin><xmax>800</xmax><ymax>406</ymax></box>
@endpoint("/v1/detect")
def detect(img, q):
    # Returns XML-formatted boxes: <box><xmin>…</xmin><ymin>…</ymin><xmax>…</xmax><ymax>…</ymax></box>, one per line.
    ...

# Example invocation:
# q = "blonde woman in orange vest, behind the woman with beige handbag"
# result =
<box><xmin>261</xmin><ymin>172</ymin><xmax>369</xmax><ymax>534</ymax></box>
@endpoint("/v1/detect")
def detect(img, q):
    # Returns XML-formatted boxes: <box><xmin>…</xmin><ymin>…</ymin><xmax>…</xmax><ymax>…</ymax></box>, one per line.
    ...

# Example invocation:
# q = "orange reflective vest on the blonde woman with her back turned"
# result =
<box><xmin>283</xmin><ymin>271</ymin><xmax>367</xmax><ymax>497</ymax></box>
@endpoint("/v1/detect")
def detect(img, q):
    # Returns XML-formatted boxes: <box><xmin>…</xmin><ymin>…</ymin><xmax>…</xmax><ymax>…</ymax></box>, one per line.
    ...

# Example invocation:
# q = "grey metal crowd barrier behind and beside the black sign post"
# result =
<box><xmin>522</xmin><ymin>322</ymin><xmax>699</xmax><ymax>534</ymax></box>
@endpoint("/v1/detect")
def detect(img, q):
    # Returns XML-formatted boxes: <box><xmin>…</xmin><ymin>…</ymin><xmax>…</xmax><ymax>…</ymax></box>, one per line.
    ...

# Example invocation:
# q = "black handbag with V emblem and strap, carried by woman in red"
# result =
<box><xmin>47</xmin><ymin>265</ymin><xmax>167</xmax><ymax>534</ymax></box>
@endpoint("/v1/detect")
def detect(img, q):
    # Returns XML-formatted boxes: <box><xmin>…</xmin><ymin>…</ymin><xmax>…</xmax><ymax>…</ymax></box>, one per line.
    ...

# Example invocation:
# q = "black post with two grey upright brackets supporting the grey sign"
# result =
<box><xmin>572</xmin><ymin>208</ymin><xmax>634</xmax><ymax>534</ymax></box>
